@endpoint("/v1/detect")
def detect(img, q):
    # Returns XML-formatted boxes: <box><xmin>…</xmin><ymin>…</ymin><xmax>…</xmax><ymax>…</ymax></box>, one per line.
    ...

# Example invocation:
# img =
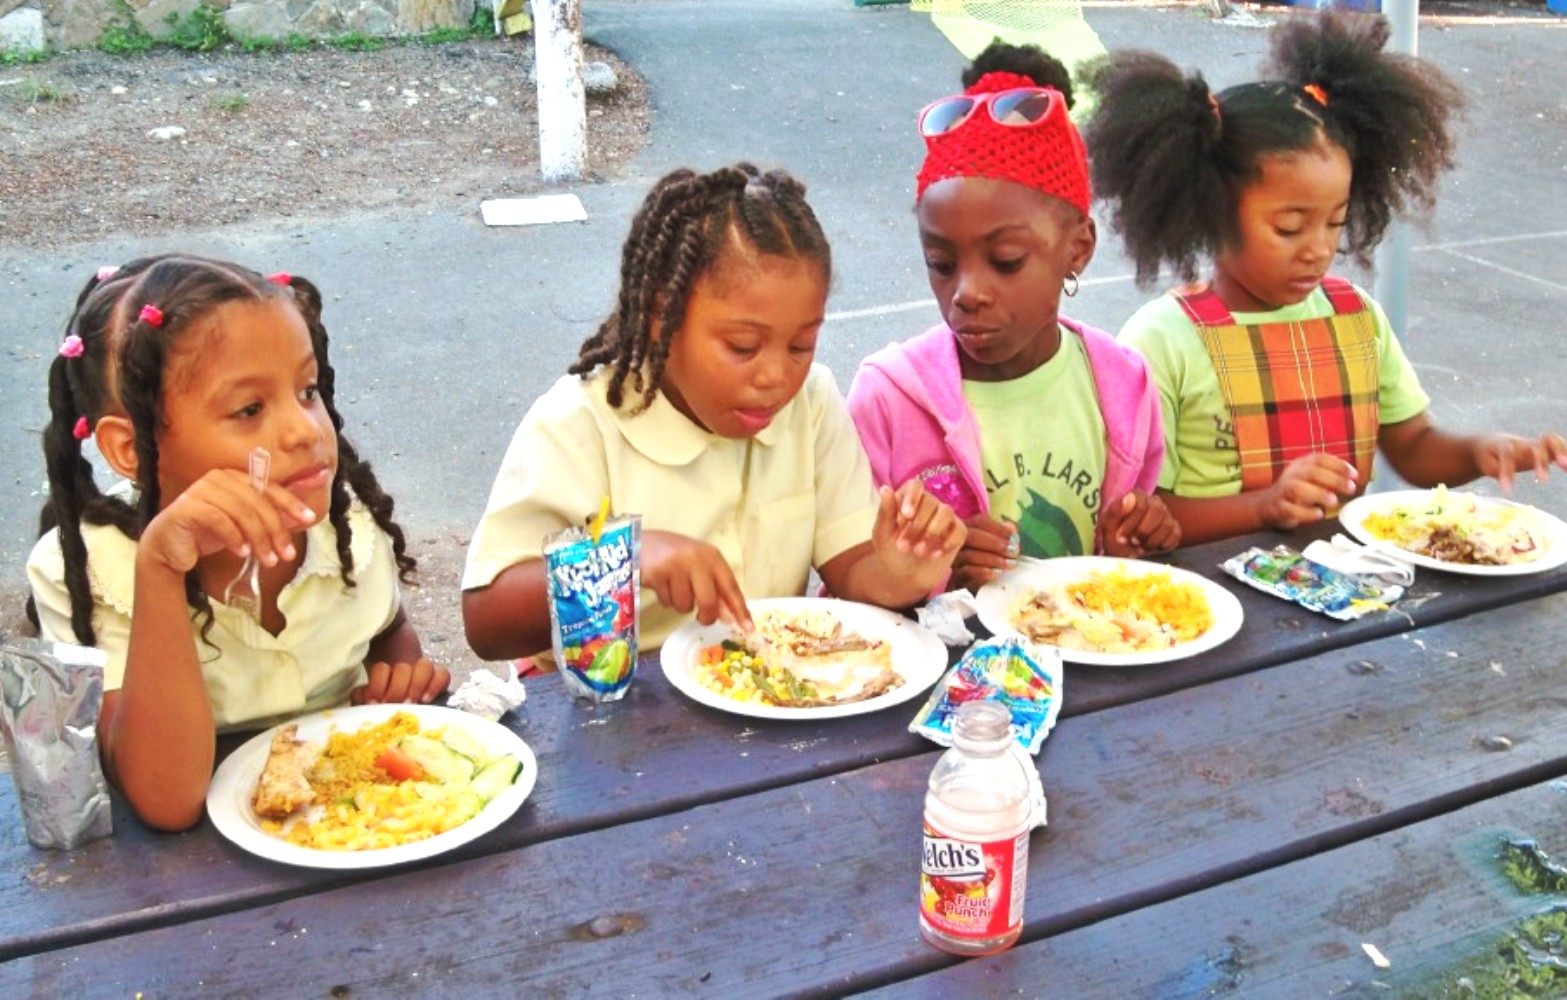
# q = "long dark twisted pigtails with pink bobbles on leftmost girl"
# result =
<box><xmin>28</xmin><ymin>254</ymin><xmax>417</xmax><ymax>646</ymax></box>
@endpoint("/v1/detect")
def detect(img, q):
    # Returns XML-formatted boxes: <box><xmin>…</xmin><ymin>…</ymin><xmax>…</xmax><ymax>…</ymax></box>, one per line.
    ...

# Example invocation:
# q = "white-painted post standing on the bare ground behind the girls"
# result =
<box><xmin>533</xmin><ymin>0</ymin><xmax>588</xmax><ymax>180</ymax></box>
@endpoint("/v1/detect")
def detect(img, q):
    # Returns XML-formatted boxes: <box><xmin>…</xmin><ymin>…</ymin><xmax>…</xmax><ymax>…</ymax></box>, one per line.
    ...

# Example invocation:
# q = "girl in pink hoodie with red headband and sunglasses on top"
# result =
<box><xmin>849</xmin><ymin>42</ymin><xmax>1180</xmax><ymax>586</ymax></box>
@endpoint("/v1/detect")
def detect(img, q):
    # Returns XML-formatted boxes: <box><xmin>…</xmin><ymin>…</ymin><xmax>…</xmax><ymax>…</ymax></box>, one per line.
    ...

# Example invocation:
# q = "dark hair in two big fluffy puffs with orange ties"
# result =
<box><xmin>1084</xmin><ymin>11</ymin><xmax>1464</xmax><ymax>285</ymax></box>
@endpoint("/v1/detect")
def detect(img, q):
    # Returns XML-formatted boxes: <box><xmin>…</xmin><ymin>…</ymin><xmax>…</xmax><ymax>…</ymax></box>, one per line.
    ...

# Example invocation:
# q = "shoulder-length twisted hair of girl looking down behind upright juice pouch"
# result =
<box><xmin>569</xmin><ymin>163</ymin><xmax>832</xmax><ymax>414</ymax></box>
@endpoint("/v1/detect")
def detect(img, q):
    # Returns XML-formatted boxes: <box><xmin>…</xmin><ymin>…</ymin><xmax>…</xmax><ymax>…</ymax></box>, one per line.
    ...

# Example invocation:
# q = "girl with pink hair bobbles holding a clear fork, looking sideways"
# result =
<box><xmin>28</xmin><ymin>255</ymin><xmax>450</xmax><ymax>829</ymax></box>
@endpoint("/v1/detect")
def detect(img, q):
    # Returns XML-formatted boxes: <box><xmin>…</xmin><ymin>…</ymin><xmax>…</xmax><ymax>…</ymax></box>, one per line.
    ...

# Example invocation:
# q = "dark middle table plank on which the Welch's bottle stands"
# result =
<box><xmin>0</xmin><ymin>597</ymin><xmax>1567</xmax><ymax>995</ymax></box>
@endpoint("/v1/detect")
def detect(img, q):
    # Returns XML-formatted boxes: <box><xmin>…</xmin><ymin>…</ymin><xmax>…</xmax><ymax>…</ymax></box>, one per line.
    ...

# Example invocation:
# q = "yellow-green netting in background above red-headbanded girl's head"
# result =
<box><xmin>909</xmin><ymin>0</ymin><xmax>1105</xmax><ymax>121</ymax></box>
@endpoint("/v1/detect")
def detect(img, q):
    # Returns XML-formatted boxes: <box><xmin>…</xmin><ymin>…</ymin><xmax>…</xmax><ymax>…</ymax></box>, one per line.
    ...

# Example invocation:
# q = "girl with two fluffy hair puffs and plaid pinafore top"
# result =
<box><xmin>1086</xmin><ymin>13</ymin><xmax>1567</xmax><ymax>542</ymax></box>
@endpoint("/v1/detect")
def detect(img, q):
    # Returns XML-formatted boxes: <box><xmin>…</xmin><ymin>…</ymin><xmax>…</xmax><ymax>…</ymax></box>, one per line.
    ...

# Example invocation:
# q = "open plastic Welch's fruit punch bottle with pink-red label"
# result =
<box><xmin>920</xmin><ymin>701</ymin><xmax>1031</xmax><ymax>955</ymax></box>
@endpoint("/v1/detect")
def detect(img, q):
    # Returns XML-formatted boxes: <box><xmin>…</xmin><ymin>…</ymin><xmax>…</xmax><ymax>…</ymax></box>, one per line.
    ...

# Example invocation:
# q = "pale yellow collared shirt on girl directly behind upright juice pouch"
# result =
<box><xmin>462</xmin><ymin>365</ymin><xmax>876</xmax><ymax>649</ymax></box>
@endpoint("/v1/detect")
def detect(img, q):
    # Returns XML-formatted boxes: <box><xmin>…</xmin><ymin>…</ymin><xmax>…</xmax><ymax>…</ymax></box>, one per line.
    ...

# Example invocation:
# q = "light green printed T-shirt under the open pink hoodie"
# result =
<box><xmin>964</xmin><ymin>331</ymin><xmax>1105</xmax><ymax>558</ymax></box>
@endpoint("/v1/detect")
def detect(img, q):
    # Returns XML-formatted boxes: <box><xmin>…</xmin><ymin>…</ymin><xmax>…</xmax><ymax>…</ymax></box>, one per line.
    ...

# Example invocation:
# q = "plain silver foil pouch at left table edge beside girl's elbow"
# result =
<box><xmin>0</xmin><ymin>639</ymin><xmax>114</xmax><ymax>851</ymax></box>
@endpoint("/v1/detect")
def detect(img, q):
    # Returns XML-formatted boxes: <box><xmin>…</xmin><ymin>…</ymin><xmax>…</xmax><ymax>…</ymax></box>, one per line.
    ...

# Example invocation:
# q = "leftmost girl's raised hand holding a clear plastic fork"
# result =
<box><xmin>138</xmin><ymin>469</ymin><xmax>317</xmax><ymax>574</ymax></box>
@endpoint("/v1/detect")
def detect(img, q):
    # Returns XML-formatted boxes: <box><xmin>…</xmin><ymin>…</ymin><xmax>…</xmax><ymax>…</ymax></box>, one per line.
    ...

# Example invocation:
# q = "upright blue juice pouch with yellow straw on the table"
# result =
<box><xmin>544</xmin><ymin>514</ymin><xmax>642</xmax><ymax>701</ymax></box>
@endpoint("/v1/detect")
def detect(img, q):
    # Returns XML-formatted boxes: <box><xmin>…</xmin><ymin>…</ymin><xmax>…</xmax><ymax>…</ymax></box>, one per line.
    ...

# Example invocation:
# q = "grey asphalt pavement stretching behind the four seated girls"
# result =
<box><xmin>0</xmin><ymin>0</ymin><xmax>1567</xmax><ymax>621</ymax></box>
